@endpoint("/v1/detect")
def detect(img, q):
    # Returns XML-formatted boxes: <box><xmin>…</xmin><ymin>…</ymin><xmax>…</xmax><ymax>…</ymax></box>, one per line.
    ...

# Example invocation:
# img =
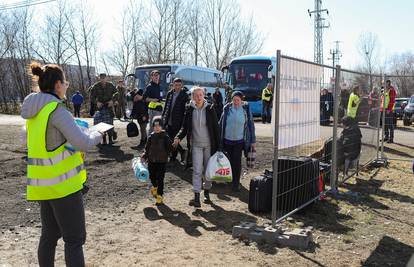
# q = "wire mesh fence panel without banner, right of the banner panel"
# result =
<box><xmin>333</xmin><ymin>69</ymin><xmax>382</xmax><ymax>185</ymax></box>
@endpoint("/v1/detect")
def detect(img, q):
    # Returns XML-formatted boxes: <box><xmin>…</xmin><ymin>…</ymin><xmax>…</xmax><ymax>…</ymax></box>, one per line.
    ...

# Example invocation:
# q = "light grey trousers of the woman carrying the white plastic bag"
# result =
<box><xmin>192</xmin><ymin>145</ymin><xmax>211</xmax><ymax>193</ymax></box>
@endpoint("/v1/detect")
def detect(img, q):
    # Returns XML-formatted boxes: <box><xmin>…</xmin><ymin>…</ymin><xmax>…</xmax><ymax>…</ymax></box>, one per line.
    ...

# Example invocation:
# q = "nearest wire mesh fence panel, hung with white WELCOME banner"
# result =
<box><xmin>272</xmin><ymin>53</ymin><xmax>335</xmax><ymax>224</ymax></box>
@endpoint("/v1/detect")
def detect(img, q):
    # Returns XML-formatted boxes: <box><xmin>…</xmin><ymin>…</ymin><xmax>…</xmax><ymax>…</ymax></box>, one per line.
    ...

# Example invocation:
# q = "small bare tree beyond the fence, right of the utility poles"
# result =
<box><xmin>358</xmin><ymin>32</ymin><xmax>379</xmax><ymax>89</ymax></box>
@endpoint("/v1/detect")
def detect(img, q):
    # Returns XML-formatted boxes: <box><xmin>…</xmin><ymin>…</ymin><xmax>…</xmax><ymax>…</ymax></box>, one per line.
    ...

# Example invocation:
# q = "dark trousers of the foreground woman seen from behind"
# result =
<box><xmin>37</xmin><ymin>191</ymin><xmax>86</xmax><ymax>267</ymax></box>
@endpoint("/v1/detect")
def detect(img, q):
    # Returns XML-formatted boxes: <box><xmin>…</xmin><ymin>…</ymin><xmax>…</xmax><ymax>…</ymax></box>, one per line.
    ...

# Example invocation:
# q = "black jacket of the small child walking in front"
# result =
<box><xmin>142</xmin><ymin>131</ymin><xmax>172</xmax><ymax>163</ymax></box>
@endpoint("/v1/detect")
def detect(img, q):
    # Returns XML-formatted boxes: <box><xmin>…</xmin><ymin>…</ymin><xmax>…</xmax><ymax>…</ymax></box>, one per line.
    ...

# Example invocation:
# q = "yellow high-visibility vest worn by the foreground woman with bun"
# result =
<box><xmin>26</xmin><ymin>102</ymin><xmax>86</xmax><ymax>200</ymax></box>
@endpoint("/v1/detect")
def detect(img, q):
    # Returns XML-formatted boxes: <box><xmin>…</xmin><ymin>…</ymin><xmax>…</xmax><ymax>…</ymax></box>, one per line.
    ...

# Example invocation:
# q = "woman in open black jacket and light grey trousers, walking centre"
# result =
<box><xmin>174</xmin><ymin>87</ymin><xmax>220</xmax><ymax>207</ymax></box>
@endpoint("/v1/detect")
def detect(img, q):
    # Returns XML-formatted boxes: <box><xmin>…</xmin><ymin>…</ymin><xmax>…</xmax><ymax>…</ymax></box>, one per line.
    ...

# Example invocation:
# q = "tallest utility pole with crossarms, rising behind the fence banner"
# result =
<box><xmin>308</xmin><ymin>0</ymin><xmax>329</xmax><ymax>64</ymax></box>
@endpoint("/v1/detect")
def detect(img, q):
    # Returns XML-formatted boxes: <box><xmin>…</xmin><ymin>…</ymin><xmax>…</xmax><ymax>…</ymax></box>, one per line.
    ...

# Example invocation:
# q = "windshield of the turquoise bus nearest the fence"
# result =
<box><xmin>229</xmin><ymin>63</ymin><xmax>268</xmax><ymax>90</ymax></box>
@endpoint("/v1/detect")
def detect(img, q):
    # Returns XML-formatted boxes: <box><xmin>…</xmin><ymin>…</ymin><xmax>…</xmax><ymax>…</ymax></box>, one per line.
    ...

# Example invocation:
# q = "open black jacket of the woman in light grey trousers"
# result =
<box><xmin>177</xmin><ymin>103</ymin><xmax>220</xmax><ymax>155</ymax></box>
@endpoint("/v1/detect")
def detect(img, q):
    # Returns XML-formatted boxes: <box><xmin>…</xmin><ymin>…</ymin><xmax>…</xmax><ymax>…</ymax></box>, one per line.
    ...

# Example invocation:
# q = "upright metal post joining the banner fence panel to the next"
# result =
<box><xmin>330</xmin><ymin>65</ymin><xmax>341</xmax><ymax>192</ymax></box>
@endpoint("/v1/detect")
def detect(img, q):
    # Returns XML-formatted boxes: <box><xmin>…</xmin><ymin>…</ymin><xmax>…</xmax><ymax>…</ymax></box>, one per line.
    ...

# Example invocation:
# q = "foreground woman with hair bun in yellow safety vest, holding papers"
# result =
<box><xmin>21</xmin><ymin>63</ymin><xmax>102</xmax><ymax>266</ymax></box>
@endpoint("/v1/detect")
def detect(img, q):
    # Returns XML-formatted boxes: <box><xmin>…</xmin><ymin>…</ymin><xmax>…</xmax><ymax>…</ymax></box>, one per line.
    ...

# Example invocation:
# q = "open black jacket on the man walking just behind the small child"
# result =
<box><xmin>162</xmin><ymin>89</ymin><xmax>188</xmax><ymax>130</ymax></box>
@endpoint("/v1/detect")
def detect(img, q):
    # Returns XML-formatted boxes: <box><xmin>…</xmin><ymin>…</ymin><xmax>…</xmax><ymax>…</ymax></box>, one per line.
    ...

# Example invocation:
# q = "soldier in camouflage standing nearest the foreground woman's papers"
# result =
<box><xmin>89</xmin><ymin>73</ymin><xmax>117</xmax><ymax>144</ymax></box>
